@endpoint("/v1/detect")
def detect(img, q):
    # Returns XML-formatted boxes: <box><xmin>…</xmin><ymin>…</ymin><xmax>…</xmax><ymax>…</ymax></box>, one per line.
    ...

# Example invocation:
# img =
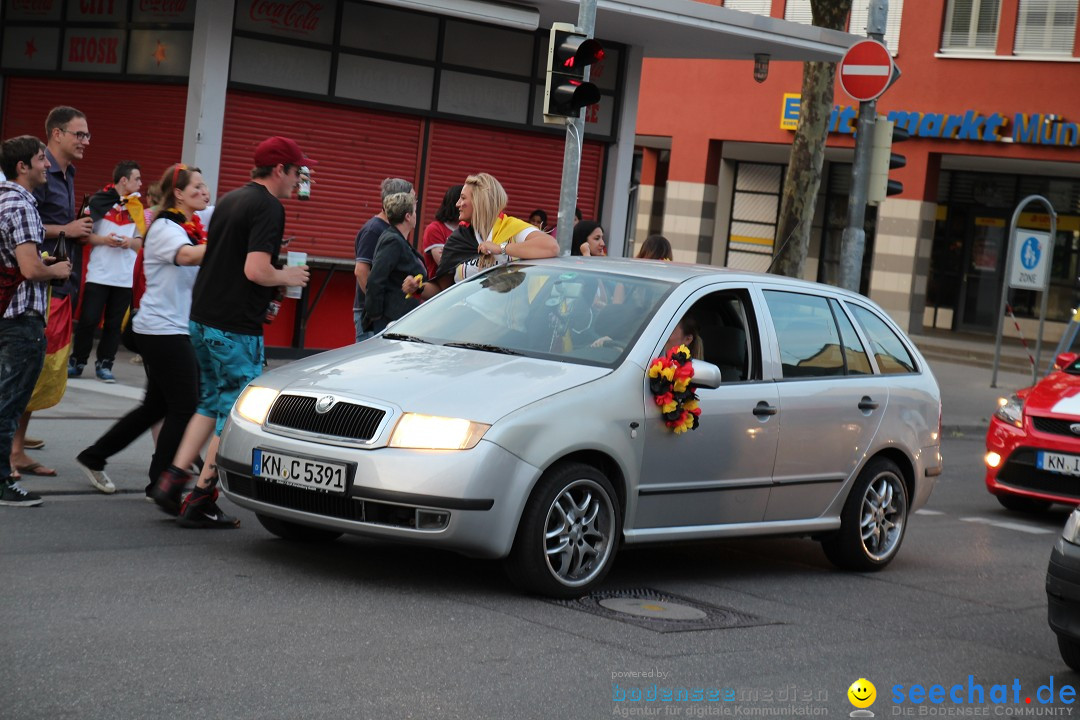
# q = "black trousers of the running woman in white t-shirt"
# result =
<box><xmin>79</xmin><ymin>334</ymin><xmax>199</xmax><ymax>484</ymax></box>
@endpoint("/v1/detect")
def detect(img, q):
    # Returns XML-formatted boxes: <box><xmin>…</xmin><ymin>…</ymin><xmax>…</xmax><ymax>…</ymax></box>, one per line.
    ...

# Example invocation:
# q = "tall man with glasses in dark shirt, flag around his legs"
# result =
<box><xmin>11</xmin><ymin>106</ymin><xmax>116</xmax><ymax>492</ymax></box>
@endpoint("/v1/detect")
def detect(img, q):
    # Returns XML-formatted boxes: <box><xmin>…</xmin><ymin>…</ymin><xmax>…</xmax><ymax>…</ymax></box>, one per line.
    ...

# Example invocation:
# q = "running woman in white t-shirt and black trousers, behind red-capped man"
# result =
<box><xmin>76</xmin><ymin>163</ymin><xmax>207</xmax><ymax>495</ymax></box>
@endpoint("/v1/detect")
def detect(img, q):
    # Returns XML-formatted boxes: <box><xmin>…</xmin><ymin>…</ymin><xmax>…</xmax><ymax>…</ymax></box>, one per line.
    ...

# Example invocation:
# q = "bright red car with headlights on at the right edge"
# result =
<box><xmin>985</xmin><ymin>353</ymin><xmax>1080</xmax><ymax>512</ymax></box>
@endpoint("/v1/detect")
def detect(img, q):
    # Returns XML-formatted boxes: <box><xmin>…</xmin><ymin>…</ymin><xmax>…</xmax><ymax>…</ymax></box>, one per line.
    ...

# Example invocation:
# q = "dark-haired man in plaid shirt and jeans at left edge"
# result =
<box><xmin>0</xmin><ymin>135</ymin><xmax>71</xmax><ymax>507</ymax></box>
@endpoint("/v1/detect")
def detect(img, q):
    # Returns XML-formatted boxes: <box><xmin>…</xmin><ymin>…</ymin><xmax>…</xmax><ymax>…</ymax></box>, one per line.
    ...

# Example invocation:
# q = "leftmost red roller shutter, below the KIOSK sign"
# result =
<box><xmin>0</xmin><ymin>77</ymin><xmax>188</xmax><ymax>203</ymax></box>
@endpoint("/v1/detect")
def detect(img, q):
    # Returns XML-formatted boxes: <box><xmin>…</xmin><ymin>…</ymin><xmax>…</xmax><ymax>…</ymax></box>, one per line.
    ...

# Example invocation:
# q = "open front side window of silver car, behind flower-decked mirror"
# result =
<box><xmin>684</xmin><ymin>289</ymin><xmax>760</xmax><ymax>383</ymax></box>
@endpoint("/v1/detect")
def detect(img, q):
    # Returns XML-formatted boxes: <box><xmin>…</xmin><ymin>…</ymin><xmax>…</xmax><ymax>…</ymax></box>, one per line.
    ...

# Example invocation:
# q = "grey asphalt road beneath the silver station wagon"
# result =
<box><xmin>0</xmin><ymin>425</ymin><xmax>1080</xmax><ymax>720</ymax></box>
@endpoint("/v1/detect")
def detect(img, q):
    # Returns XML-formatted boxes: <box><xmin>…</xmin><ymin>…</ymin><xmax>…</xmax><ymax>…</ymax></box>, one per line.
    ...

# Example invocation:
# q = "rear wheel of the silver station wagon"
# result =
<box><xmin>821</xmin><ymin>458</ymin><xmax>908</xmax><ymax>572</ymax></box>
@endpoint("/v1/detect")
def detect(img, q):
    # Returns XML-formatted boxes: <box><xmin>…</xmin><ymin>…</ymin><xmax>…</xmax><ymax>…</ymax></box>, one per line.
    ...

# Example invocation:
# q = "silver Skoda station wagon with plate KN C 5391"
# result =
<box><xmin>218</xmin><ymin>258</ymin><xmax>942</xmax><ymax>597</ymax></box>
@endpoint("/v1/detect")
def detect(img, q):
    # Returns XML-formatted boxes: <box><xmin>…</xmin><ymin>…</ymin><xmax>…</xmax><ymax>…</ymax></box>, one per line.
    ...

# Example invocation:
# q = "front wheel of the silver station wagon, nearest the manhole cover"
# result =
<box><xmin>505</xmin><ymin>463</ymin><xmax>622</xmax><ymax>598</ymax></box>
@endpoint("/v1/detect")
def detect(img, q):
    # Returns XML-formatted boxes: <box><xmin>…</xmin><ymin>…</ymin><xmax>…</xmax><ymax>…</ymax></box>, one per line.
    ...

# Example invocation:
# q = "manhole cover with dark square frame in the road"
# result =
<box><xmin>553</xmin><ymin>587</ymin><xmax>779</xmax><ymax>633</ymax></box>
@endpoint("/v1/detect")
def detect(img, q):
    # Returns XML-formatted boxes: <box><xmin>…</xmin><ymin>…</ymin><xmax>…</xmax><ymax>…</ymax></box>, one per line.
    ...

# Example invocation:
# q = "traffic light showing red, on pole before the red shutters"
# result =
<box><xmin>543</xmin><ymin>23</ymin><xmax>604</xmax><ymax>125</ymax></box>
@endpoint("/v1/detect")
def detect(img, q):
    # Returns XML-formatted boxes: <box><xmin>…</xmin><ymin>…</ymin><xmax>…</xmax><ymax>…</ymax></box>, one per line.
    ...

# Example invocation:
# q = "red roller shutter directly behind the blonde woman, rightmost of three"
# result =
<box><xmin>420</xmin><ymin>120</ymin><xmax>604</xmax><ymax>231</ymax></box>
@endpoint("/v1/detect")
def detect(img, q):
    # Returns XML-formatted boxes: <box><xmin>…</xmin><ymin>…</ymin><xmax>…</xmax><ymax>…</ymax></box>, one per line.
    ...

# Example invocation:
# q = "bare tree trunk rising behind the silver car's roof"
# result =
<box><xmin>773</xmin><ymin>0</ymin><xmax>851</xmax><ymax>277</ymax></box>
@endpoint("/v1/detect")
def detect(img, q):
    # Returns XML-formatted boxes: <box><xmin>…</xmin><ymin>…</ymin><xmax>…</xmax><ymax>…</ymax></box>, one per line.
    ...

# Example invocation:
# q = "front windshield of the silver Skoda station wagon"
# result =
<box><xmin>388</xmin><ymin>263</ymin><xmax>673</xmax><ymax>367</ymax></box>
